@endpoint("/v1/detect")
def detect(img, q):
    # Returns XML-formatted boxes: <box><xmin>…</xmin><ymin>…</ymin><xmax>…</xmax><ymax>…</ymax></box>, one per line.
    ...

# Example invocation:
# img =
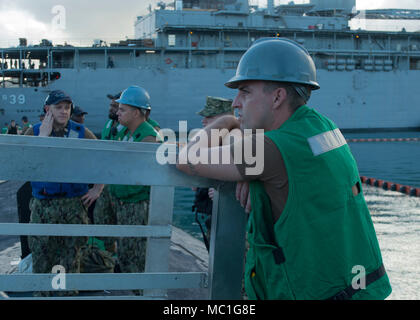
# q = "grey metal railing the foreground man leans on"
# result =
<box><xmin>0</xmin><ymin>135</ymin><xmax>246</xmax><ymax>300</ymax></box>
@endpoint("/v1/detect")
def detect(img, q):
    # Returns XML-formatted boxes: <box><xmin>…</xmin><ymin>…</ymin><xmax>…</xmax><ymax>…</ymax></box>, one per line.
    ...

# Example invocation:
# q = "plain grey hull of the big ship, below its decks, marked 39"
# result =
<box><xmin>0</xmin><ymin>68</ymin><xmax>420</xmax><ymax>133</ymax></box>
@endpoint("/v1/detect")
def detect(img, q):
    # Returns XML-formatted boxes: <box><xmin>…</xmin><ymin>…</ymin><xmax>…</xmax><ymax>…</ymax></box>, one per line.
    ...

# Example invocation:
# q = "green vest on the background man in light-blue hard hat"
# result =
<box><xmin>109</xmin><ymin>122</ymin><xmax>161</xmax><ymax>203</ymax></box>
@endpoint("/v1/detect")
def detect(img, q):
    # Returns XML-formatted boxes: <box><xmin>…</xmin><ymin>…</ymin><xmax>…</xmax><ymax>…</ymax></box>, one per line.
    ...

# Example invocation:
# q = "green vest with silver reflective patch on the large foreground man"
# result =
<box><xmin>245</xmin><ymin>106</ymin><xmax>391</xmax><ymax>300</ymax></box>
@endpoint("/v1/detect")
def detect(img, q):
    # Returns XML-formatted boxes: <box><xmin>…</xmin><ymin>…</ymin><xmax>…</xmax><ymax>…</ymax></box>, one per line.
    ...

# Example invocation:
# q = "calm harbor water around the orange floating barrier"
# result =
<box><xmin>174</xmin><ymin>132</ymin><xmax>420</xmax><ymax>300</ymax></box>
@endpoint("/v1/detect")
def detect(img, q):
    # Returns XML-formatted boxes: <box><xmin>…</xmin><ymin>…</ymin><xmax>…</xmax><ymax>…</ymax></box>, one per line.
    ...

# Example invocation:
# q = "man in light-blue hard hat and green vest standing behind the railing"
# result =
<box><xmin>99</xmin><ymin>86</ymin><xmax>162</xmax><ymax>288</ymax></box>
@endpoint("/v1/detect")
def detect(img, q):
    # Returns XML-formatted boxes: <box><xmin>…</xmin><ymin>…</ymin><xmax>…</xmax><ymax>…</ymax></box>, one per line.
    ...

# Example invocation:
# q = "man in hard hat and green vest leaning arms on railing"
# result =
<box><xmin>177</xmin><ymin>38</ymin><xmax>391</xmax><ymax>300</ymax></box>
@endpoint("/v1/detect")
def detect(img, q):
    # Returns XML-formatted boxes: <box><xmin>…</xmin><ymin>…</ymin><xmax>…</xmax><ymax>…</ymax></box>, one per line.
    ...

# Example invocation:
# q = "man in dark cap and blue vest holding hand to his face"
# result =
<box><xmin>25</xmin><ymin>90</ymin><xmax>102</xmax><ymax>296</ymax></box>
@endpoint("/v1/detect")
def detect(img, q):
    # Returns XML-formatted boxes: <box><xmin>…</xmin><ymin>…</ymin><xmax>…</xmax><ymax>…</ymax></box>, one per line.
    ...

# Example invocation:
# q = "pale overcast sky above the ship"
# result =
<box><xmin>0</xmin><ymin>0</ymin><xmax>420</xmax><ymax>47</ymax></box>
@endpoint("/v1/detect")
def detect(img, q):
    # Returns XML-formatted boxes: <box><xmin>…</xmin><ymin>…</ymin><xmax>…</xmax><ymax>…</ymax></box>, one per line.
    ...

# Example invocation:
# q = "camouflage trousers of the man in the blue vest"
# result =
<box><xmin>28</xmin><ymin>198</ymin><xmax>88</xmax><ymax>296</ymax></box>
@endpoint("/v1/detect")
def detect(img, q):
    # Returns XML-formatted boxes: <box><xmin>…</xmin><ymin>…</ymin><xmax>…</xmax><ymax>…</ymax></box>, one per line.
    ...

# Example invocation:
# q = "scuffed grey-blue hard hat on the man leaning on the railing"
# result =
<box><xmin>225</xmin><ymin>38</ymin><xmax>320</xmax><ymax>90</ymax></box>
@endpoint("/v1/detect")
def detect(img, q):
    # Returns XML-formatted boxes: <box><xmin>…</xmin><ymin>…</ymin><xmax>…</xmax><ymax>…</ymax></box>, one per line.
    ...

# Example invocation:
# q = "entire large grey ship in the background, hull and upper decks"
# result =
<box><xmin>0</xmin><ymin>0</ymin><xmax>420</xmax><ymax>132</ymax></box>
